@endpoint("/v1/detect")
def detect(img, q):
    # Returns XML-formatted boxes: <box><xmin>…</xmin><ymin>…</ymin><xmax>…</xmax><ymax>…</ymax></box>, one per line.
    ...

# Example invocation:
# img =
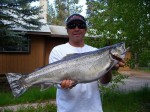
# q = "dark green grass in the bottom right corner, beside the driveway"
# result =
<box><xmin>103</xmin><ymin>87</ymin><xmax>150</xmax><ymax>112</ymax></box>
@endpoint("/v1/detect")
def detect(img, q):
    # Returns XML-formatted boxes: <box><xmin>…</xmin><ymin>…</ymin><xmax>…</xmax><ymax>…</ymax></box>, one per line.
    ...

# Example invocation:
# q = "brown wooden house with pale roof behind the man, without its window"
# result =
<box><xmin>0</xmin><ymin>25</ymin><xmax>68</xmax><ymax>74</ymax></box>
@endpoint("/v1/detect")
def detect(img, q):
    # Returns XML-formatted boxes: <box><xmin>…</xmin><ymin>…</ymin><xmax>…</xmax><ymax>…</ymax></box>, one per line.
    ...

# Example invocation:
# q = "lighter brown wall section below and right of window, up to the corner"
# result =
<box><xmin>0</xmin><ymin>37</ymin><xmax>44</xmax><ymax>74</ymax></box>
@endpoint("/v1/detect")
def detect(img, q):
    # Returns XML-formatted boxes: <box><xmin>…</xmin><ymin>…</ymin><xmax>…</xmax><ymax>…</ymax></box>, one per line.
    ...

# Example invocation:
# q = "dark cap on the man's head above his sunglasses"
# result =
<box><xmin>66</xmin><ymin>14</ymin><xmax>86</xmax><ymax>26</ymax></box>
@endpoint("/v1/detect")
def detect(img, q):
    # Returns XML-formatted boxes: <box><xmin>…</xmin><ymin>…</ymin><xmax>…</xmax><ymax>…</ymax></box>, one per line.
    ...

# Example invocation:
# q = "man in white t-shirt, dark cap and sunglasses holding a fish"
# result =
<box><xmin>49</xmin><ymin>14</ymin><xmax>124</xmax><ymax>112</ymax></box>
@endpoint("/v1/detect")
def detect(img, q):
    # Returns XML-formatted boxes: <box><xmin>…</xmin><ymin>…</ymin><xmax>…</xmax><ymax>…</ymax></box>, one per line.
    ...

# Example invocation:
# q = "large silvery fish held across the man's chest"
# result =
<box><xmin>6</xmin><ymin>43</ymin><xmax>126</xmax><ymax>97</ymax></box>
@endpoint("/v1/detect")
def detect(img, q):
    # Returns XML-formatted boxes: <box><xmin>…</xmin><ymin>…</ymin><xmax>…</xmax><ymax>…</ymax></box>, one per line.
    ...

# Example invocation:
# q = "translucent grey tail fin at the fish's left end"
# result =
<box><xmin>6</xmin><ymin>73</ymin><xmax>27</xmax><ymax>97</ymax></box>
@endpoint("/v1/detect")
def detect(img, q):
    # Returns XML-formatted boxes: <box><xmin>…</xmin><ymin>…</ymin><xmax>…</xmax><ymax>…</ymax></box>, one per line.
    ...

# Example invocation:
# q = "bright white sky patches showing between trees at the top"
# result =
<box><xmin>31</xmin><ymin>0</ymin><xmax>87</xmax><ymax>16</ymax></box>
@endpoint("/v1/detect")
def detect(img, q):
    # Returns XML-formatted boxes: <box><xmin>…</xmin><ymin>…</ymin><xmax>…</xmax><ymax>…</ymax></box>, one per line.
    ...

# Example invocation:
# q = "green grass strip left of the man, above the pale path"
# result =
<box><xmin>0</xmin><ymin>87</ymin><xmax>56</xmax><ymax>106</ymax></box>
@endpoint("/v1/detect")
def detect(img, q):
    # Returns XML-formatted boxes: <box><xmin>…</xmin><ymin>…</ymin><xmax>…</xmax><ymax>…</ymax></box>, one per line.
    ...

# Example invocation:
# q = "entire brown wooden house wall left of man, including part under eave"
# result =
<box><xmin>0</xmin><ymin>35</ymin><xmax>68</xmax><ymax>74</ymax></box>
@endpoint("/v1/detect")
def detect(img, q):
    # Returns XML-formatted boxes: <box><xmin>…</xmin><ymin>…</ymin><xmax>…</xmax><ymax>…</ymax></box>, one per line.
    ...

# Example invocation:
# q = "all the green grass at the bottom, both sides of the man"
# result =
<box><xmin>0</xmin><ymin>87</ymin><xmax>150</xmax><ymax>112</ymax></box>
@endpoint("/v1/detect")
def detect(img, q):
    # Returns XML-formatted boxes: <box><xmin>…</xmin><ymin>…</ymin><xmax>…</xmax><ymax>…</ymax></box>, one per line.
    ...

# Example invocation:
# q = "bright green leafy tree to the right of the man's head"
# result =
<box><xmin>88</xmin><ymin>0</ymin><xmax>150</xmax><ymax>67</ymax></box>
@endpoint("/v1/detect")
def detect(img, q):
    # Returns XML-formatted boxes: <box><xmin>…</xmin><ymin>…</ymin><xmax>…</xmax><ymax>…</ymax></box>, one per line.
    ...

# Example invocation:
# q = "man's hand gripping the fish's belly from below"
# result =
<box><xmin>61</xmin><ymin>80</ymin><xmax>75</xmax><ymax>89</ymax></box>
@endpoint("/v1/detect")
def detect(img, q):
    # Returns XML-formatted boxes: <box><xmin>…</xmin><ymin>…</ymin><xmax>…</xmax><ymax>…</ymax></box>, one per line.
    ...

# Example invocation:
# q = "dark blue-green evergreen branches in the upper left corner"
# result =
<box><xmin>0</xmin><ymin>0</ymin><xmax>43</xmax><ymax>50</ymax></box>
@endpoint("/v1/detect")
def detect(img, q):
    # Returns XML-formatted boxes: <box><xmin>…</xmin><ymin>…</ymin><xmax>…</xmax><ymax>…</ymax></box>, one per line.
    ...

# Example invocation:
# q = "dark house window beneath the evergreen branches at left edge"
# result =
<box><xmin>0</xmin><ymin>36</ymin><xmax>30</xmax><ymax>53</ymax></box>
